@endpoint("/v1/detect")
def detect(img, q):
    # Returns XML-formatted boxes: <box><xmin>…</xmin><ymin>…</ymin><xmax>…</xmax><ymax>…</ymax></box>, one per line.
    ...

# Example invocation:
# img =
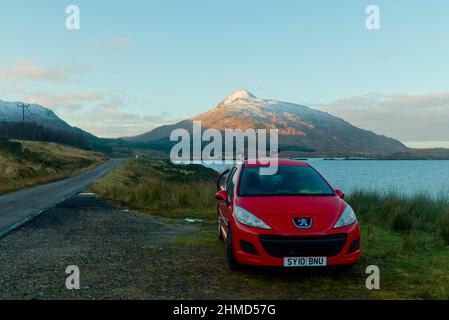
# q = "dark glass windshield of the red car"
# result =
<box><xmin>239</xmin><ymin>166</ymin><xmax>334</xmax><ymax>197</ymax></box>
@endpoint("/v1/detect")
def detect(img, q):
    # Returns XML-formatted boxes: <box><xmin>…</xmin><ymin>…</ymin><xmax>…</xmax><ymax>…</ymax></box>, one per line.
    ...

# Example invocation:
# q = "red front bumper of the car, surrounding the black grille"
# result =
<box><xmin>232</xmin><ymin>222</ymin><xmax>361</xmax><ymax>267</ymax></box>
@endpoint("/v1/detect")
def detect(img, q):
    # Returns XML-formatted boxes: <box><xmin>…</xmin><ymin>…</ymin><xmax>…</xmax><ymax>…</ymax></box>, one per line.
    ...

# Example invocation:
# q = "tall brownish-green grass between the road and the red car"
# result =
<box><xmin>90</xmin><ymin>158</ymin><xmax>217</xmax><ymax>219</ymax></box>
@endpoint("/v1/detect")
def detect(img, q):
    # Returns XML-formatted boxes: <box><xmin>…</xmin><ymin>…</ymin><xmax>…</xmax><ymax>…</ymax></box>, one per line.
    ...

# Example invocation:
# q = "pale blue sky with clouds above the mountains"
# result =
<box><xmin>0</xmin><ymin>0</ymin><xmax>449</xmax><ymax>147</ymax></box>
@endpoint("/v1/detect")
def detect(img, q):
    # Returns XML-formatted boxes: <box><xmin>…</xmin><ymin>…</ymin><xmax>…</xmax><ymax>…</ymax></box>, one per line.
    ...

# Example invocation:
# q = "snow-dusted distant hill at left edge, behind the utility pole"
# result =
<box><xmin>0</xmin><ymin>100</ymin><xmax>74</xmax><ymax>131</ymax></box>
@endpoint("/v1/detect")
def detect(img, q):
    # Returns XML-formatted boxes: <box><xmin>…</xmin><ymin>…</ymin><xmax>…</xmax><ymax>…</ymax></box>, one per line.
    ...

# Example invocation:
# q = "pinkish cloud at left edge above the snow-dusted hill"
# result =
<box><xmin>0</xmin><ymin>59</ymin><xmax>83</xmax><ymax>82</ymax></box>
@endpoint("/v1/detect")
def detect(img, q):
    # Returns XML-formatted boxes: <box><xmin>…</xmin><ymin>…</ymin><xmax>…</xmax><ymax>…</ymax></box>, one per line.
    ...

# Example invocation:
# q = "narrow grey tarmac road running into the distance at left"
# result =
<box><xmin>0</xmin><ymin>160</ymin><xmax>121</xmax><ymax>238</ymax></box>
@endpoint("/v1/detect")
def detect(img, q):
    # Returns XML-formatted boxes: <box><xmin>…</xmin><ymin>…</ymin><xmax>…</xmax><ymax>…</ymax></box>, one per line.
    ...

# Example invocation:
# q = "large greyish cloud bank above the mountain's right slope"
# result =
<box><xmin>318</xmin><ymin>92</ymin><xmax>449</xmax><ymax>141</ymax></box>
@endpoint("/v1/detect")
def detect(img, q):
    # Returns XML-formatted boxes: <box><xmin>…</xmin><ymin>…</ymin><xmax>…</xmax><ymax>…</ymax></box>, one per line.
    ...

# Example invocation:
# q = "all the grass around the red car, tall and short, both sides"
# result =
<box><xmin>92</xmin><ymin>159</ymin><xmax>449</xmax><ymax>299</ymax></box>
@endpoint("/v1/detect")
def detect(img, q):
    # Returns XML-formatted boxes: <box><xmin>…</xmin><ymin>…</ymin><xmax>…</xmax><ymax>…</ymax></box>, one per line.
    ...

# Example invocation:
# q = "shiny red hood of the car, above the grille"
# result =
<box><xmin>235</xmin><ymin>196</ymin><xmax>347</xmax><ymax>234</ymax></box>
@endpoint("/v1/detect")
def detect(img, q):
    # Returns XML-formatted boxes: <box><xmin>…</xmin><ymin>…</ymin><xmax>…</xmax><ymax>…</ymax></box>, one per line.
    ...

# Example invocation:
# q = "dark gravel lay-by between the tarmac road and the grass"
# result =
<box><xmin>0</xmin><ymin>194</ymin><xmax>196</xmax><ymax>299</ymax></box>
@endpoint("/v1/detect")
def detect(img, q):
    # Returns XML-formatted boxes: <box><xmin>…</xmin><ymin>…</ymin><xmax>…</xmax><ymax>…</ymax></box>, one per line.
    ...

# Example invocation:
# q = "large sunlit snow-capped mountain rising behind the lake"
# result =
<box><xmin>132</xmin><ymin>90</ymin><xmax>408</xmax><ymax>153</ymax></box>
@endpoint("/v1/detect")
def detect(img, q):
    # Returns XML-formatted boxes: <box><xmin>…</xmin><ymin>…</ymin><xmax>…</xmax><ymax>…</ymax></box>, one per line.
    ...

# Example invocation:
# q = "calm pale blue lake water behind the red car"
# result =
<box><xmin>205</xmin><ymin>159</ymin><xmax>449</xmax><ymax>196</ymax></box>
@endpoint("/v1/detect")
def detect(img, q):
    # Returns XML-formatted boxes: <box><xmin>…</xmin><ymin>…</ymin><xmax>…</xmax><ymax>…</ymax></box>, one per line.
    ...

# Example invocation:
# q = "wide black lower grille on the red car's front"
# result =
<box><xmin>259</xmin><ymin>234</ymin><xmax>348</xmax><ymax>258</ymax></box>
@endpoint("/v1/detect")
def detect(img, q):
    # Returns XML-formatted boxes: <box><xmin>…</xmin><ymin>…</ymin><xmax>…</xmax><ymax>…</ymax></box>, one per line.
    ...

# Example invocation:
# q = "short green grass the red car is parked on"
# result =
<box><xmin>166</xmin><ymin>225</ymin><xmax>449</xmax><ymax>300</ymax></box>
